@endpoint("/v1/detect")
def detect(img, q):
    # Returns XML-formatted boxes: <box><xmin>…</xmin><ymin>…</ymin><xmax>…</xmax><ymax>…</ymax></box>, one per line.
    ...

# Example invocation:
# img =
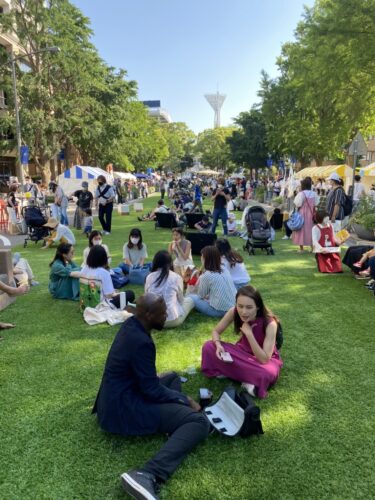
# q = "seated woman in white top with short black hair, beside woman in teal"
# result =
<box><xmin>80</xmin><ymin>245</ymin><xmax>135</xmax><ymax>309</ymax></box>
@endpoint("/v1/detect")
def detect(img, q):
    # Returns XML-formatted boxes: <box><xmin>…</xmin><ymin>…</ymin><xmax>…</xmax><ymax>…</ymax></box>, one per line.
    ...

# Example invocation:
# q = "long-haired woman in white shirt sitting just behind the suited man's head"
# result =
<box><xmin>145</xmin><ymin>250</ymin><xmax>194</xmax><ymax>328</ymax></box>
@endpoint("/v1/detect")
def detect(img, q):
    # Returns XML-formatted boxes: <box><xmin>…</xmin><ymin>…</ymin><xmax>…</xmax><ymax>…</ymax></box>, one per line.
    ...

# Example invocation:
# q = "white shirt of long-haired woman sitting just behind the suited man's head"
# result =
<box><xmin>145</xmin><ymin>271</ymin><xmax>184</xmax><ymax>321</ymax></box>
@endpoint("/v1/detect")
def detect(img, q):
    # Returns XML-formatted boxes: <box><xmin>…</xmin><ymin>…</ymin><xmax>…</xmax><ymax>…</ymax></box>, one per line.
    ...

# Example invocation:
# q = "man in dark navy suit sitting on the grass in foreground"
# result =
<box><xmin>93</xmin><ymin>293</ymin><xmax>209</xmax><ymax>500</ymax></box>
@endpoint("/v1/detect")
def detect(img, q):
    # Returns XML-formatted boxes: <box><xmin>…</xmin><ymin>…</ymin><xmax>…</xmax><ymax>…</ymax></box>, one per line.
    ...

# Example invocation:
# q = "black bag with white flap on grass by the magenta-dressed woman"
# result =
<box><xmin>204</xmin><ymin>386</ymin><xmax>264</xmax><ymax>437</ymax></box>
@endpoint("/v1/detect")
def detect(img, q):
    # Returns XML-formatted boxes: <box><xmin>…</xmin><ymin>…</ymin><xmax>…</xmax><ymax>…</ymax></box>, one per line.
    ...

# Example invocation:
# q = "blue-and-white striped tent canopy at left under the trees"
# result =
<box><xmin>57</xmin><ymin>165</ymin><xmax>113</xmax><ymax>196</ymax></box>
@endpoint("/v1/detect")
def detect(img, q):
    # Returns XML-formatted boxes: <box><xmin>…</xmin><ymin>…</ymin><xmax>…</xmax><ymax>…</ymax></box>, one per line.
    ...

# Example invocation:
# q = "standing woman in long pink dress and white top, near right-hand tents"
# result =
<box><xmin>292</xmin><ymin>177</ymin><xmax>319</xmax><ymax>253</ymax></box>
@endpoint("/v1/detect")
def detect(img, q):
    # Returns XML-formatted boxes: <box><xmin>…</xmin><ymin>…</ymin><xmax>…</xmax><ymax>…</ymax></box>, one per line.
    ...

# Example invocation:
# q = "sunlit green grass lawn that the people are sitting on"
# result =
<box><xmin>0</xmin><ymin>193</ymin><xmax>375</xmax><ymax>500</ymax></box>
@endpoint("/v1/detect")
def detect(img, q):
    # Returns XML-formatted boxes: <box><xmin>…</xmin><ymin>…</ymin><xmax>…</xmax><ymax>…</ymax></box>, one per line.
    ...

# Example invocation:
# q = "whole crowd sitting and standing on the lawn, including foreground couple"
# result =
<box><xmin>0</xmin><ymin>169</ymin><xmax>375</xmax><ymax>499</ymax></box>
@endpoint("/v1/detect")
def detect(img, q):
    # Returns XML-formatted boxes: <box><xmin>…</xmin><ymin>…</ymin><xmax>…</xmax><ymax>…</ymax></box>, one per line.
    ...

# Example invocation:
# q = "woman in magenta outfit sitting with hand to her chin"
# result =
<box><xmin>202</xmin><ymin>285</ymin><xmax>283</xmax><ymax>398</ymax></box>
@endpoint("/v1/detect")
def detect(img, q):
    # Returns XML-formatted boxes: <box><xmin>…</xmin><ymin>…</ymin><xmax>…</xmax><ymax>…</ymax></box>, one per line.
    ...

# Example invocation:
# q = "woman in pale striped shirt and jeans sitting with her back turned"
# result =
<box><xmin>189</xmin><ymin>246</ymin><xmax>236</xmax><ymax>318</ymax></box>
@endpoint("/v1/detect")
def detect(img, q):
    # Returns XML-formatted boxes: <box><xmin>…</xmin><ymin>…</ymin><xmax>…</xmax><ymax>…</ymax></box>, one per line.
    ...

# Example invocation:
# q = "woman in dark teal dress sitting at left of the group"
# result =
<box><xmin>48</xmin><ymin>243</ymin><xmax>80</xmax><ymax>300</ymax></box>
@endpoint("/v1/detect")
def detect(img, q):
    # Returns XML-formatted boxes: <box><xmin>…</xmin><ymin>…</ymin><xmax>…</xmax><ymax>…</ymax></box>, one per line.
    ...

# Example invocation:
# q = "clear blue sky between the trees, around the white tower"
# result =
<box><xmin>73</xmin><ymin>0</ymin><xmax>314</xmax><ymax>132</ymax></box>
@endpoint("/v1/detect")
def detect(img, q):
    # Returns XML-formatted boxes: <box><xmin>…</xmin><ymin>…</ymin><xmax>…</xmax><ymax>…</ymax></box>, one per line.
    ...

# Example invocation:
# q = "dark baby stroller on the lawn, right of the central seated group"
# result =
<box><xmin>243</xmin><ymin>207</ymin><xmax>275</xmax><ymax>255</ymax></box>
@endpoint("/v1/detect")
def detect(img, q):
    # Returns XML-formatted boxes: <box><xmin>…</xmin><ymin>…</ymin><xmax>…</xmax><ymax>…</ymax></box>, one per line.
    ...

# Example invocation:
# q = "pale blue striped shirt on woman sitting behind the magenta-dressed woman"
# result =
<box><xmin>198</xmin><ymin>269</ymin><xmax>237</xmax><ymax>311</ymax></box>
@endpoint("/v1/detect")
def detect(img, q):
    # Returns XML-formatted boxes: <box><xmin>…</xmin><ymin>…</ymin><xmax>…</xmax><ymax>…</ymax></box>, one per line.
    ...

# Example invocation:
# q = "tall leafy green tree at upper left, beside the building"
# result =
<box><xmin>0</xmin><ymin>0</ymin><xmax>136</xmax><ymax>180</ymax></box>
